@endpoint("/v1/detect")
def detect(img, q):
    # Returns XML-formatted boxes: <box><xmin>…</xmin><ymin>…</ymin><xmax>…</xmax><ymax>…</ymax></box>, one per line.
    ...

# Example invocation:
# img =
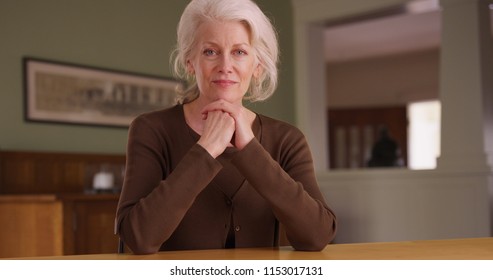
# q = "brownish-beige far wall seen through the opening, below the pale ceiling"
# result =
<box><xmin>326</xmin><ymin>49</ymin><xmax>440</xmax><ymax>108</ymax></box>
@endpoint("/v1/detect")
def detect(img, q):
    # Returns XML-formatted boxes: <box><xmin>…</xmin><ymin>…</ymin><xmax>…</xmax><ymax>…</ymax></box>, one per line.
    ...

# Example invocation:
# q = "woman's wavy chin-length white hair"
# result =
<box><xmin>171</xmin><ymin>0</ymin><xmax>279</xmax><ymax>103</ymax></box>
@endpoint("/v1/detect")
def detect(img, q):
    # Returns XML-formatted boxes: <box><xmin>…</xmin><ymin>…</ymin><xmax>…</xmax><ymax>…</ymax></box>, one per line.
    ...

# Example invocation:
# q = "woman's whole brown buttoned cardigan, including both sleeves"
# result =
<box><xmin>115</xmin><ymin>105</ymin><xmax>336</xmax><ymax>254</ymax></box>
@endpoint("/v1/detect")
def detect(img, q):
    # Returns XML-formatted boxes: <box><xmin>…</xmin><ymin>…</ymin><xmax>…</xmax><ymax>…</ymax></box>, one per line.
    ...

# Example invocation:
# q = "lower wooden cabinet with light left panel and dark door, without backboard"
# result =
<box><xmin>0</xmin><ymin>194</ymin><xmax>118</xmax><ymax>258</ymax></box>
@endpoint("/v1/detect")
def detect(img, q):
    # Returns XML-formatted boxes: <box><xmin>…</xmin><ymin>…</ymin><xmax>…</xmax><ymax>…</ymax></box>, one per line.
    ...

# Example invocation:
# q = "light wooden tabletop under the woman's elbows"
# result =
<box><xmin>6</xmin><ymin>237</ymin><xmax>493</xmax><ymax>260</ymax></box>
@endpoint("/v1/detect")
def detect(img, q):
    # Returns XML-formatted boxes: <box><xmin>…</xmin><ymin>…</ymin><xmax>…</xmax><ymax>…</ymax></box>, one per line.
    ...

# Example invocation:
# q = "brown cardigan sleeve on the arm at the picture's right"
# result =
<box><xmin>232</xmin><ymin>135</ymin><xmax>336</xmax><ymax>251</ymax></box>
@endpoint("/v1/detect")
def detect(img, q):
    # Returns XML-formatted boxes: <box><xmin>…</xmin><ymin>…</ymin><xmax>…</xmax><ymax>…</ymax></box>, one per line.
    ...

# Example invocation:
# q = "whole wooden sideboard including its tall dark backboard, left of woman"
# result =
<box><xmin>0</xmin><ymin>151</ymin><xmax>125</xmax><ymax>257</ymax></box>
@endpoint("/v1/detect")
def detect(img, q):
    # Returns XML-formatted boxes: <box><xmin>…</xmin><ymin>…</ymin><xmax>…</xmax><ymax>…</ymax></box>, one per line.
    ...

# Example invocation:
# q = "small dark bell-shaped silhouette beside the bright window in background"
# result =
<box><xmin>368</xmin><ymin>127</ymin><xmax>402</xmax><ymax>167</ymax></box>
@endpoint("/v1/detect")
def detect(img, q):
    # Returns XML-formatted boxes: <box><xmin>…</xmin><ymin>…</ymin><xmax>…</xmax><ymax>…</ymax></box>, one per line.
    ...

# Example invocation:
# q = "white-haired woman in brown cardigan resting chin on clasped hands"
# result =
<box><xmin>115</xmin><ymin>0</ymin><xmax>336</xmax><ymax>254</ymax></box>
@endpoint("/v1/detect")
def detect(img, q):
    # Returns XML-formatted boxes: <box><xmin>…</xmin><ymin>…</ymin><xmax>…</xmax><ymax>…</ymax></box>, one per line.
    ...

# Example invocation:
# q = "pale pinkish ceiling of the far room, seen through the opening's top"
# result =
<box><xmin>324</xmin><ymin>0</ymin><xmax>490</xmax><ymax>62</ymax></box>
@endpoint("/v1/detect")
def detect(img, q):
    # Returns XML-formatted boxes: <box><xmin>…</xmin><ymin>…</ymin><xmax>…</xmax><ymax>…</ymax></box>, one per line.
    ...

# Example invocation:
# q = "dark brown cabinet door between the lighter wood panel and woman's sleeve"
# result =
<box><xmin>73</xmin><ymin>200</ymin><xmax>118</xmax><ymax>254</ymax></box>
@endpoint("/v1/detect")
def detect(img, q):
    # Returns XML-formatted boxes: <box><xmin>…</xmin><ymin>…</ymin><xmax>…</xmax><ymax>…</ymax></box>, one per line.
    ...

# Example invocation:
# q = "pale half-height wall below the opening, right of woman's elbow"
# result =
<box><xmin>318</xmin><ymin>169</ymin><xmax>492</xmax><ymax>243</ymax></box>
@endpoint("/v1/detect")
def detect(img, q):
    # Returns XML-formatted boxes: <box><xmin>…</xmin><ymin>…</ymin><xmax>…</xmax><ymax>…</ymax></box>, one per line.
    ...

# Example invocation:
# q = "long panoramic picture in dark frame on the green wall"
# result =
<box><xmin>23</xmin><ymin>57</ymin><xmax>183</xmax><ymax>127</ymax></box>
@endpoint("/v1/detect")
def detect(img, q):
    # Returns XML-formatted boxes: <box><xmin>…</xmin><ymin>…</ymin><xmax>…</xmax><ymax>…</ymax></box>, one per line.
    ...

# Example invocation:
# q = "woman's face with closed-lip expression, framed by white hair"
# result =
<box><xmin>187</xmin><ymin>21</ymin><xmax>260</xmax><ymax>104</ymax></box>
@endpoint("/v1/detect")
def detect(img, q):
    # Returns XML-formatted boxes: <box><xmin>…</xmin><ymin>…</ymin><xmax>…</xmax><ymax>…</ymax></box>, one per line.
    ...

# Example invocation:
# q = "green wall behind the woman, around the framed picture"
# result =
<box><xmin>0</xmin><ymin>0</ymin><xmax>295</xmax><ymax>153</ymax></box>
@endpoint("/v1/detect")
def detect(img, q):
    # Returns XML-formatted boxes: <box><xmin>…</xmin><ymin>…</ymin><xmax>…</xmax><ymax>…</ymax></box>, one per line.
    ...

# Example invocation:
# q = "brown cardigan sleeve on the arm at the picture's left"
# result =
<box><xmin>115</xmin><ymin>115</ymin><xmax>222</xmax><ymax>254</ymax></box>
